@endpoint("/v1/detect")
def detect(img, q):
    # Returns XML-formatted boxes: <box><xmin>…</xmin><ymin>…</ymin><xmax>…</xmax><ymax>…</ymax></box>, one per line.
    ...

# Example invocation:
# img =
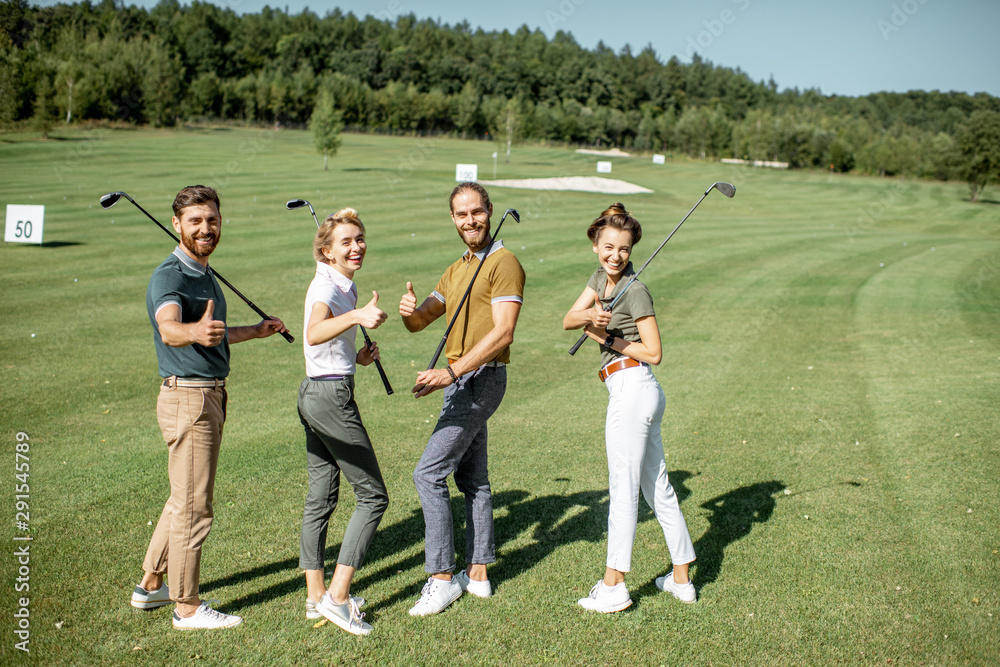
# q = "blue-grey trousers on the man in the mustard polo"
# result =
<box><xmin>413</xmin><ymin>366</ymin><xmax>507</xmax><ymax>574</ymax></box>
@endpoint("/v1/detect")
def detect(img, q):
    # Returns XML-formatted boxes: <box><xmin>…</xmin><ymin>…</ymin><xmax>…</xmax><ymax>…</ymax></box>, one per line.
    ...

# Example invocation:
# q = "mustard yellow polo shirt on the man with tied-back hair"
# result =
<box><xmin>431</xmin><ymin>241</ymin><xmax>524</xmax><ymax>364</ymax></box>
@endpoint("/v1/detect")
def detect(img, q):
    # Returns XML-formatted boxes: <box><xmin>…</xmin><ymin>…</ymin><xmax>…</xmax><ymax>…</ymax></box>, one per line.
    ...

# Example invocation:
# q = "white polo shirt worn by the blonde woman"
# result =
<box><xmin>302</xmin><ymin>262</ymin><xmax>358</xmax><ymax>377</ymax></box>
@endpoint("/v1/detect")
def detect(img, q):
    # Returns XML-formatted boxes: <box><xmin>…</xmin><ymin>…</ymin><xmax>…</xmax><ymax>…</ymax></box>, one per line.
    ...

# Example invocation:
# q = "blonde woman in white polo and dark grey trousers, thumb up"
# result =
<box><xmin>298</xmin><ymin>208</ymin><xmax>389</xmax><ymax>635</ymax></box>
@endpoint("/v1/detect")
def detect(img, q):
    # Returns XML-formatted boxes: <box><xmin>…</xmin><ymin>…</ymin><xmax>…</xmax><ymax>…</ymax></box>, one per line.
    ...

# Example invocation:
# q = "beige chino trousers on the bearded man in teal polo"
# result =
<box><xmin>142</xmin><ymin>384</ymin><xmax>227</xmax><ymax>604</ymax></box>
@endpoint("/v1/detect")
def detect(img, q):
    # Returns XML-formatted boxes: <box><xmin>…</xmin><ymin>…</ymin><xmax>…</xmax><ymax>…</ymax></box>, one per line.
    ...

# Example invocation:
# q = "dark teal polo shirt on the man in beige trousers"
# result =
<box><xmin>146</xmin><ymin>246</ymin><xmax>229</xmax><ymax>378</ymax></box>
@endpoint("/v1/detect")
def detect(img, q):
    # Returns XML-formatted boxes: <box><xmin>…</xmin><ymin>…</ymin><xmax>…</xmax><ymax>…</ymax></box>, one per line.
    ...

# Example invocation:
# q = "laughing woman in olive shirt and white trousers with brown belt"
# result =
<box><xmin>563</xmin><ymin>204</ymin><xmax>697</xmax><ymax>613</ymax></box>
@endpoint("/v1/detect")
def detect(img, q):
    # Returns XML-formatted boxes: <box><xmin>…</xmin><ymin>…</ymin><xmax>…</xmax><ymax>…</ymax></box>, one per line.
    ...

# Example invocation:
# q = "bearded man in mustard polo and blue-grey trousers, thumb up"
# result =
<box><xmin>399</xmin><ymin>183</ymin><xmax>524</xmax><ymax>616</ymax></box>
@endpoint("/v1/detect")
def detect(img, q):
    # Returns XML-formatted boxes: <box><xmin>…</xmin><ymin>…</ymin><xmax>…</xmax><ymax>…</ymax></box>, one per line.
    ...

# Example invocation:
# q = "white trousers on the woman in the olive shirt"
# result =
<box><xmin>604</xmin><ymin>366</ymin><xmax>695</xmax><ymax>572</ymax></box>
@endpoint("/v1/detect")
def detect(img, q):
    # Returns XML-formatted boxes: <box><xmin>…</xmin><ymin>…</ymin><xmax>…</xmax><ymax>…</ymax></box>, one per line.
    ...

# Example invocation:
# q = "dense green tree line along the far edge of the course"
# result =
<box><xmin>0</xmin><ymin>0</ymin><xmax>1000</xmax><ymax>198</ymax></box>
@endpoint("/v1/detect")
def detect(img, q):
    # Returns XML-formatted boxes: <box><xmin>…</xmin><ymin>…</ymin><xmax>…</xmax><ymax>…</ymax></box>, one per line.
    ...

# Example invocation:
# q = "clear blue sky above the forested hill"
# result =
<box><xmin>34</xmin><ymin>0</ymin><xmax>1000</xmax><ymax>96</ymax></box>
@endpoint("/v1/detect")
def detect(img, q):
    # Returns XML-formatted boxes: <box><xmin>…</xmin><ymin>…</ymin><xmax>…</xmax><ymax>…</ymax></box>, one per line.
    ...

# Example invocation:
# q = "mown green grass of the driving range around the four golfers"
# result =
<box><xmin>0</xmin><ymin>128</ymin><xmax>1000</xmax><ymax>665</ymax></box>
